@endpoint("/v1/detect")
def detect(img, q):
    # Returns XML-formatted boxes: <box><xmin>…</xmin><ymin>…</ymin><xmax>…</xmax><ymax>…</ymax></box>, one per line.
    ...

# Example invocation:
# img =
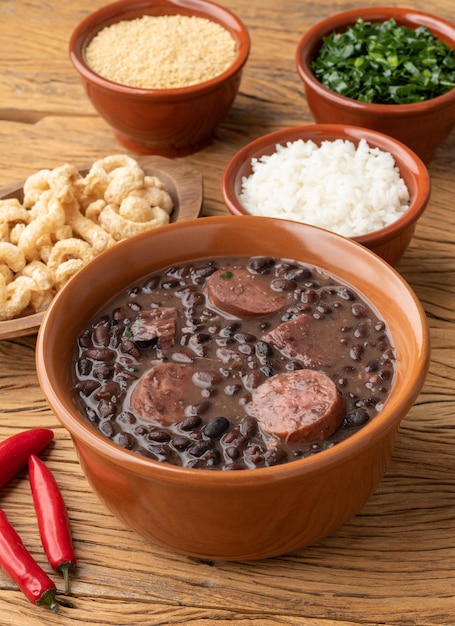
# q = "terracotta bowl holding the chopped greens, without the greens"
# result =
<box><xmin>295</xmin><ymin>7</ymin><xmax>455</xmax><ymax>163</ymax></box>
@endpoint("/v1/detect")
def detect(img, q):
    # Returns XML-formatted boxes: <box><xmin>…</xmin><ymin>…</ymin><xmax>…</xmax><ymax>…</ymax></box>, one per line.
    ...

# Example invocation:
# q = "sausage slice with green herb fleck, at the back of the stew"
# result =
<box><xmin>207</xmin><ymin>267</ymin><xmax>286</xmax><ymax>317</ymax></box>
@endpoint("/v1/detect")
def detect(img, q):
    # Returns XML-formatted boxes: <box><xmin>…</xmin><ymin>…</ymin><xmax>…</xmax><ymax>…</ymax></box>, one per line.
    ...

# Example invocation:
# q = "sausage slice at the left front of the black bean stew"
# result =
<box><xmin>130</xmin><ymin>363</ymin><xmax>193</xmax><ymax>425</ymax></box>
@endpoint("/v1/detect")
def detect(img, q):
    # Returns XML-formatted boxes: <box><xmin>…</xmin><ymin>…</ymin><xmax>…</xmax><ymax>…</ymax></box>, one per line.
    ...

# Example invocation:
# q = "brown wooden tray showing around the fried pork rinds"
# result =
<box><xmin>0</xmin><ymin>156</ymin><xmax>203</xmax><ymax>340</ymax></box>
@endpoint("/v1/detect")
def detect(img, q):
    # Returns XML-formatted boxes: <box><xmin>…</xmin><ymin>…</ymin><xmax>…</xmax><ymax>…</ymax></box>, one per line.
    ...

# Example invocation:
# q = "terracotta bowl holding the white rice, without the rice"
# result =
<box><xmin>221</xmin><ymin>124</ymin><xmax>431</xmax><ymax>265</ymax></box>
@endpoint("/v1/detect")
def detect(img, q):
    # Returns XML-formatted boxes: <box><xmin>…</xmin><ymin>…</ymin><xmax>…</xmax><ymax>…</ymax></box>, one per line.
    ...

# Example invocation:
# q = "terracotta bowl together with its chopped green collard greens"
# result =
<box><xmin>295</xmin><ymin>7</ymin><xmax>455</xmax><ymax>163</ymax></box>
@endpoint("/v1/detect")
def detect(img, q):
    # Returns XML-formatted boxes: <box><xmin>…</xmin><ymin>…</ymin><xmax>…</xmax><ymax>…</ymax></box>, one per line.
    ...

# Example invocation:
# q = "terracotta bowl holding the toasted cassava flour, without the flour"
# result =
<box><xmin>69</xmin><ymin>0</ymin><xmax>250</xmax><ymax>157</ymax></box>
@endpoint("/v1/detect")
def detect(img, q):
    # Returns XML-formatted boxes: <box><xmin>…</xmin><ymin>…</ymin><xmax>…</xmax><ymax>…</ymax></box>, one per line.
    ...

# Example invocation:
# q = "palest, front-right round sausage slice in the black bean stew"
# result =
<box><xmin>250</xmin><ymin>369</ymin><xmax>345</xmax><ymax>443</ymax></box>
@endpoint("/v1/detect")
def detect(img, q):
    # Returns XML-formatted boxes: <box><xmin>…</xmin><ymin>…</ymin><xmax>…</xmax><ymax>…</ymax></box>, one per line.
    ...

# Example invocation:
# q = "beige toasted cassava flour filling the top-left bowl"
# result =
<box><xmin>85</xmin><ymin>15</ymin><xmax>237</xmax><ymax>89</ymax></box>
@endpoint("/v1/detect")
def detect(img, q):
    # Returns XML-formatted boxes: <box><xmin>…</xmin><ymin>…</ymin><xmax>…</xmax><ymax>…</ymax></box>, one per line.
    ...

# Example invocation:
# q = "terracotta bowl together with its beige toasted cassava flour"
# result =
<box><xmin>69</xmin><ymin>0</ymin><xmax>250</xmax><ymax>157</ymax></box>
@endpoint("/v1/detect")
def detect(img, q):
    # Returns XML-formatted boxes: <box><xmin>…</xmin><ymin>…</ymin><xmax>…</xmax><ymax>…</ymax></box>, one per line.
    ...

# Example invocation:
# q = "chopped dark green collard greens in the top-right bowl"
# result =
<box><xmin>311</xmin><ymin>19</ymin><xmax>455</xmax><ymax>104</ymax></box>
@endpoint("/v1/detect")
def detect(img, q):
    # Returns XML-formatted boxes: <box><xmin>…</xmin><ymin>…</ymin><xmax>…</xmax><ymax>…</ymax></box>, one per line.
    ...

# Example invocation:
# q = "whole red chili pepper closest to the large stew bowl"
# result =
<box><xmin>28</xmin><ymin>454</ymin><xmax>76</xmax><ymax>593</ymax></box>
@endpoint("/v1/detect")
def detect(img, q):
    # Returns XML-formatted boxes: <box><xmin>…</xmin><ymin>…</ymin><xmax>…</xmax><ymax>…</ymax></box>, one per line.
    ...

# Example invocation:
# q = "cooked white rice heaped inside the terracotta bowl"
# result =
<box><xmin>240</xmin><ymin>139</ymin><xmax>410</xmax><ymax>237</ymax></box>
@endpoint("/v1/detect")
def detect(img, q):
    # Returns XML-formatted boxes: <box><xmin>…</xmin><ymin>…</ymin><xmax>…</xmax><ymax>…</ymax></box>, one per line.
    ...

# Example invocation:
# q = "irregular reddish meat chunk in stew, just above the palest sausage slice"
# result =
<box><xmin>261</xmin><ymin>313</ymin><xmax>331</xmax><ymax>368</ymax></box>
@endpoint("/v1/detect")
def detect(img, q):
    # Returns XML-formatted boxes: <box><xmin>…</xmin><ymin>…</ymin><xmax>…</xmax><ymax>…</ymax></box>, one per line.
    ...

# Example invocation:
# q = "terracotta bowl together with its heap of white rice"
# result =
<box><xmin>221</xmin><ymin>124</ymin><xmax>431</xmax><ymax>265</ymax></box>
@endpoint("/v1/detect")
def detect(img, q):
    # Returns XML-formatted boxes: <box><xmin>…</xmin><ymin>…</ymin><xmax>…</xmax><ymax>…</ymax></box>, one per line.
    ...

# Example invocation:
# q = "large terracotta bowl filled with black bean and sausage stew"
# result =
<box><xmin>37</xmin><ymin>216</ymin><xmax>429</xmax><ymax>559</ymax></box>
